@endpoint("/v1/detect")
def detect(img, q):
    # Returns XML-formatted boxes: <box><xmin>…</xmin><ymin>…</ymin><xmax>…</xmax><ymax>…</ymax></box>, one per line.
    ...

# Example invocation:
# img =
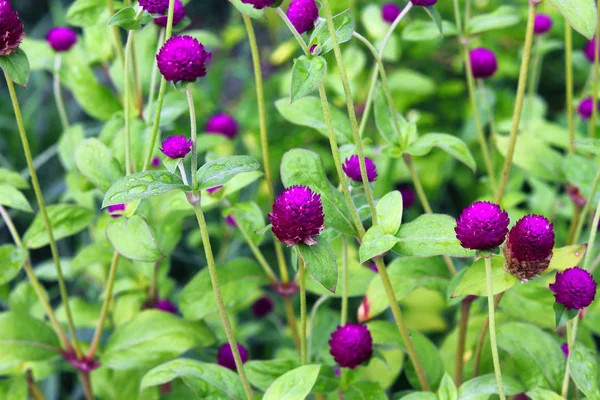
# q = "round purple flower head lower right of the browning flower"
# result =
<box><xmin>550</xmin><ymin>267</ymin><xmax>596</xmax><ymax>310</ymax></box>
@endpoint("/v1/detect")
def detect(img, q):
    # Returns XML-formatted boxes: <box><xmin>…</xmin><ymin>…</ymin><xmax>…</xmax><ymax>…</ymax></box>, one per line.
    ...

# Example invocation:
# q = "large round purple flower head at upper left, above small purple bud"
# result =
<box><xmin>156</xmin><ymin>36</ymin><xmax>211</xmax><ymax>83</ymax></box>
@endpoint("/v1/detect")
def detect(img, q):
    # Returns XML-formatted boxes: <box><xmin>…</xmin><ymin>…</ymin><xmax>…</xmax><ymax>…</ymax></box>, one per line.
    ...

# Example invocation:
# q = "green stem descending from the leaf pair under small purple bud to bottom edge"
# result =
<box><xmin>192</xmin><ymin>203</ymin><xmax>254</xmax><ymax>400</ymax></box>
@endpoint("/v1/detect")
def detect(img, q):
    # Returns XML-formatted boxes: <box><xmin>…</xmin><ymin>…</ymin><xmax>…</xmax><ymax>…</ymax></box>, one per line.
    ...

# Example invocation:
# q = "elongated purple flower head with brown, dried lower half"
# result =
<box><xmin>504</xmin><ymin>215</ymin><xmax>554</xmax><ymax>282</ymax></box>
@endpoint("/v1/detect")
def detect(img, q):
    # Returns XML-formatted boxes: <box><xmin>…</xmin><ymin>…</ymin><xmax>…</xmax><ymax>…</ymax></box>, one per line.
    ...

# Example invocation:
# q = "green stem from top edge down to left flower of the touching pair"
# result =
<box><xmin>495</xmin><ymin>1</ymin><xmax>536</xmax><ymax>204</ymax></box>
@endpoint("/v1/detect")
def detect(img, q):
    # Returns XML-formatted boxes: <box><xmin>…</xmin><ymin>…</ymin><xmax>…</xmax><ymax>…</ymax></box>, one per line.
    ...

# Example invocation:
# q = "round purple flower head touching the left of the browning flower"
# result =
<box><xmin>454</xmin><ymin>201</ymin><xmax>510</xmax><ymax>250</ymax></box>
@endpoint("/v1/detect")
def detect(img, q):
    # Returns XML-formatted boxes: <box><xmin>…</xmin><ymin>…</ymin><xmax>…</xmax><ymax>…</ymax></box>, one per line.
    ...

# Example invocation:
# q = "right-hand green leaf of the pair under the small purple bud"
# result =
<box><xmin>196</xmin><ymin>156</ymin><xmax>260</xmax><ymax>189</ymax></box>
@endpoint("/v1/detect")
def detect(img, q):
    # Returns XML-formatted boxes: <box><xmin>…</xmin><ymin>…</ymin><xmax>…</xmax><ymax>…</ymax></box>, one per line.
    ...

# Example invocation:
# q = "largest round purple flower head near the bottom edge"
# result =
<box><xmin>329</xmin><ymin>323</ymin><xmax>373</xmax><ymax>369</ymax></box>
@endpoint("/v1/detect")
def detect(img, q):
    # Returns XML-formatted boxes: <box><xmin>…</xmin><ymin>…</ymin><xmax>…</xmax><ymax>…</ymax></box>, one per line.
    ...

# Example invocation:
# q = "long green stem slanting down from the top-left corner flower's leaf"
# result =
<box><xmin>4</xmin><ymin>72</ymin><xmax>81</xmax><ymax>357</ymax></box>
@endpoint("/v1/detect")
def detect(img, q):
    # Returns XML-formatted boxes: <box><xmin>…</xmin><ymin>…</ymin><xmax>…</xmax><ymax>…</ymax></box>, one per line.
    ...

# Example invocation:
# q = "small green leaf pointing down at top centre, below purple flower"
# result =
<box><xmin>290</xmin><ymin>56</ymin><xmax>327</xmax><ymax>103</ymax></box>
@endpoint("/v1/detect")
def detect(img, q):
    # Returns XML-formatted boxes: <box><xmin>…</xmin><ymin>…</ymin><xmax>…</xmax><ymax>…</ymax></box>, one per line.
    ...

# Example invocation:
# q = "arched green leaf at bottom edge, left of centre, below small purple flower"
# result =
<box><xmin>140</xmin><ymin>358</ymin><xmax>246</xmax><ymax>400</ymax></box>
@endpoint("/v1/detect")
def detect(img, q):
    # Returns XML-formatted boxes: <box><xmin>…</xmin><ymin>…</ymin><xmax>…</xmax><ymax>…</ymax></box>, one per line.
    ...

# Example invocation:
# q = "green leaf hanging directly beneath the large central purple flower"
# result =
<box><xmin>297</xmin><ymin>237</ymin><xmax>338</xmax><ymax>293</ymax></box>
